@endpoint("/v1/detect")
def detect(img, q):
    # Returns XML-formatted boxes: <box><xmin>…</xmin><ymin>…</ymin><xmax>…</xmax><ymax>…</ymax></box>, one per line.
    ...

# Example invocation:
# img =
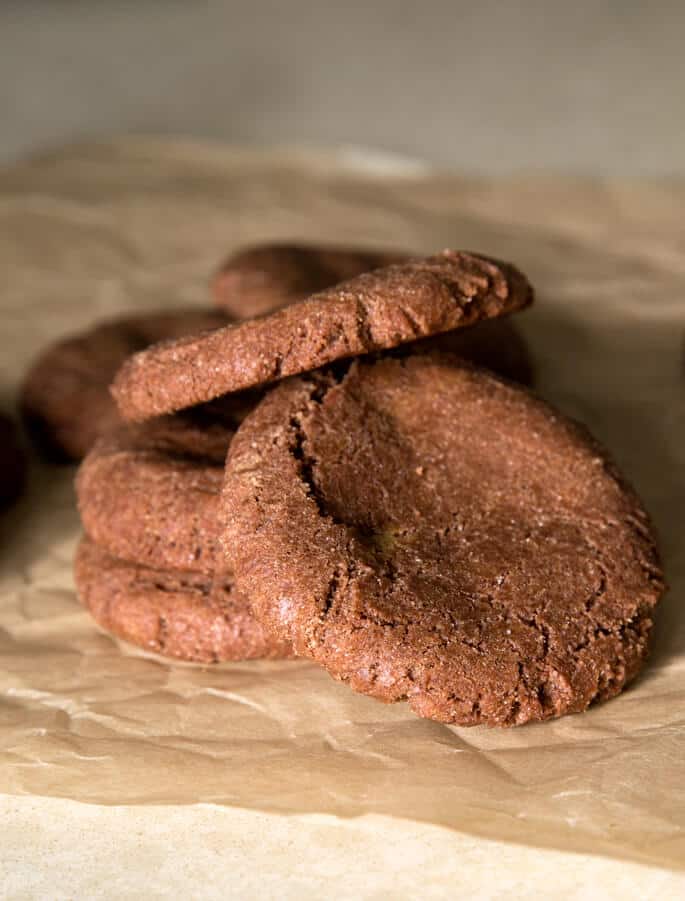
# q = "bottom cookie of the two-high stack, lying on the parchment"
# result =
<box><xmin>74</xmin><ymin>536</ymin><xmax>292</xmax><ymax>663</ymax></box>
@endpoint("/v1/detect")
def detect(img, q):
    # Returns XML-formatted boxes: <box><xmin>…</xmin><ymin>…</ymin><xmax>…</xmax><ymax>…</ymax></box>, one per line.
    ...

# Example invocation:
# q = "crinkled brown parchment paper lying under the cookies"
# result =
<box><xmin>0</xmin><ymin>139</ymin><xmax>685</xmax><ymax>869</ymax></box>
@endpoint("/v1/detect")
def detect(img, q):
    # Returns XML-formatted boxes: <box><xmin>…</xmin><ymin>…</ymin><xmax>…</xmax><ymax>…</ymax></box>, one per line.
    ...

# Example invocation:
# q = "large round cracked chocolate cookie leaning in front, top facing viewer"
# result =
<box><xmin>220</xmin><ymin>355</ymin><xmax>663</xmax><ymax>725</ymax></box>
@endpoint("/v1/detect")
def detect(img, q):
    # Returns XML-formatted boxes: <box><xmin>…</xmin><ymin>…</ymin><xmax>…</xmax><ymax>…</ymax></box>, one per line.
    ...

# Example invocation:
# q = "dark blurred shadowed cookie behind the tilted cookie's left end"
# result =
<box><xmin>21</xmin><ymin>309</ymin><xmax>230</xmax><ymax>462</ymax></box>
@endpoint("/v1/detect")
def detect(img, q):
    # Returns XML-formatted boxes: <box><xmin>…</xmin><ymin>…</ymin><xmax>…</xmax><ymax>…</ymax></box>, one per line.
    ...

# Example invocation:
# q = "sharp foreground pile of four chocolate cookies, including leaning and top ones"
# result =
<box><xmin>32</xmin><ymin>243</ymin><xmax>663</xmax><ymax>725</ymax></box>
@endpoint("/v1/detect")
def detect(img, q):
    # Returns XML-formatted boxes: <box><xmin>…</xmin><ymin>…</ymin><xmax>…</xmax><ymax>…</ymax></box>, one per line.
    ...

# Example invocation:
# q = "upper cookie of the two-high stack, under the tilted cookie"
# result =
<box><xmin>76</xmin><ymin>392</ymin><xmax>256</xmax><ymax>573</ymax></box>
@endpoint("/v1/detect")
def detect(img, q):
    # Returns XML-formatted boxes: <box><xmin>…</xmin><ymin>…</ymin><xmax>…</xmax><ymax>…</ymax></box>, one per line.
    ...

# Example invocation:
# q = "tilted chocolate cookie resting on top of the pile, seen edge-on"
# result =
<box><xmin>112</xmin><ymin>250</ymin><xmax>532</xmax><ymax>421</ymax></box>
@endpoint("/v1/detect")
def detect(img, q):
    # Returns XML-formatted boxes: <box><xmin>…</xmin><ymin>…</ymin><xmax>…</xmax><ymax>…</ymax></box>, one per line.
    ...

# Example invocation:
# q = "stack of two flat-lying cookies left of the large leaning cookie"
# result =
<box><xmin>75</xmin><ymin>401</ymin><xmax>291</xmax><ymax>663</ymax></box>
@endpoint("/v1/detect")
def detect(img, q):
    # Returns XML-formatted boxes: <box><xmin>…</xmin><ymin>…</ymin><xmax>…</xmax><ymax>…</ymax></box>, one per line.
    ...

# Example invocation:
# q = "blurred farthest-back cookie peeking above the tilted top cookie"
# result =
<box><xmin>211</xmin><ymin>244</ymin><xmax>408</xmax><ymax>319</ymax></box>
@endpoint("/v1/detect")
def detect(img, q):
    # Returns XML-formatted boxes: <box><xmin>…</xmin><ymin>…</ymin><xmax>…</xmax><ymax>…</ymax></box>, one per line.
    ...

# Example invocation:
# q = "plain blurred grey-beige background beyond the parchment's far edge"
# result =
<box><xmin>0</xmin><ymin>0</ymin><xmax>685</xmax><ymax>175</ymax></box>
